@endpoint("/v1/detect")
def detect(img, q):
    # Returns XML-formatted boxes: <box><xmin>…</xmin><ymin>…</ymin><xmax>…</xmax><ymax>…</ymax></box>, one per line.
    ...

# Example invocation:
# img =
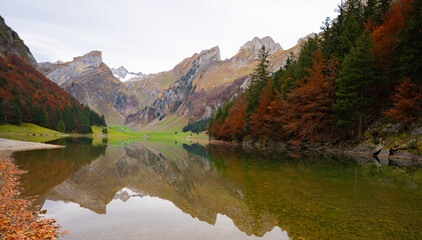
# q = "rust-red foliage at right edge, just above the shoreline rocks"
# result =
<box><xmin>384</xmin><ymin>78</ymin><xmax>422</xmax><ymax>122</ymax></box>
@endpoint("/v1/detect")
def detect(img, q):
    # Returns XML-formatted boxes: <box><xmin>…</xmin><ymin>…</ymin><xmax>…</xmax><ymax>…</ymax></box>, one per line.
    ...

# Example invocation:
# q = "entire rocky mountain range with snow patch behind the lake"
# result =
<box><xmin>38</xmin><ymin>36</ymin><xmax>300</xmax><ymax>128</ymax></box>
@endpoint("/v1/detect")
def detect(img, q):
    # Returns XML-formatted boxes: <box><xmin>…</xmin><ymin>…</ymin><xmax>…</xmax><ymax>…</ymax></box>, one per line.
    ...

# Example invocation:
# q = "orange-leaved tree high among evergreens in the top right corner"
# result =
<box><xmin>371</xmin><ymin>0</ymin><xmax>413</xmax><ymax>67</ymax></box>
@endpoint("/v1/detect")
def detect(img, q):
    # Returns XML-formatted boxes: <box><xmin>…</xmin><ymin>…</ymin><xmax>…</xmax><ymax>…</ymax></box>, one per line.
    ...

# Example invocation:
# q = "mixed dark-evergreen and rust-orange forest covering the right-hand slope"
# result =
<box><xmin>208</xmin><ymin>0</ymin><xmax>422</xmax><ymax>142</ymax></box>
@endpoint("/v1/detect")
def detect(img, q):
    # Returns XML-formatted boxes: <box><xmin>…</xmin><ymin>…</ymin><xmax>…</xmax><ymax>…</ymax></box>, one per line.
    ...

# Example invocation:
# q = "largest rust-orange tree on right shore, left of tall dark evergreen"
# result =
<box><xmin>281</xmin><ymin>51</ymin><xmax>337</xmax><ymax>142</ymax></box>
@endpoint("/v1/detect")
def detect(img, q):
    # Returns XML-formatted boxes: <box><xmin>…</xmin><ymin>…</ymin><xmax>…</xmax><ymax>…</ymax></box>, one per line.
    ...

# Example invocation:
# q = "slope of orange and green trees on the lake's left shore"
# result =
<box><xmin>0</xmin><ymin>55</ymin><xmax>106</xmax><ymax>133</ymax></box>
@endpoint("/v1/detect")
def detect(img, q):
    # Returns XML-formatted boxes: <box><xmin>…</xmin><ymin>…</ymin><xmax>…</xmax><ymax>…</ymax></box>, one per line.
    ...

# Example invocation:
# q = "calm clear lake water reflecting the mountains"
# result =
<box><xmin>14</xmin><ymin>139</ymin><xmax>422</xmax><ymax>240</ymax></box>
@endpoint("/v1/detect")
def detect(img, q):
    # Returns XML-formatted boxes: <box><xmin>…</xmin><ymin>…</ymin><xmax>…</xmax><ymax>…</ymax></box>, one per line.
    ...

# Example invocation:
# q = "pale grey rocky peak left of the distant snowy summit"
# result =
<box><xmin>38</xmin><ymin>51</ymin><xmax>124</xmax><ymax>123</ymax></box>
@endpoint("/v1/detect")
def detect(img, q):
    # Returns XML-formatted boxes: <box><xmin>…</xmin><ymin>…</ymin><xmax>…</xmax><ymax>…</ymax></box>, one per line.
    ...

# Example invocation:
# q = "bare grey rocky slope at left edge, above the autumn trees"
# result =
<box><xmin>0</xmin><ymin>16</ymin><xmax>37</xmax><ymax>68</ymax></box>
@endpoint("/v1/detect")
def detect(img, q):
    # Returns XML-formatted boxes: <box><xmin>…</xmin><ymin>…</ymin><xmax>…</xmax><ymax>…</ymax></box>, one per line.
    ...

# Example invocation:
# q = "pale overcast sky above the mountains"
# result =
<box><xmin>0</xmin><ymin>0</ymin><xmax>340</xmax><ymax>73</ymax></box>
